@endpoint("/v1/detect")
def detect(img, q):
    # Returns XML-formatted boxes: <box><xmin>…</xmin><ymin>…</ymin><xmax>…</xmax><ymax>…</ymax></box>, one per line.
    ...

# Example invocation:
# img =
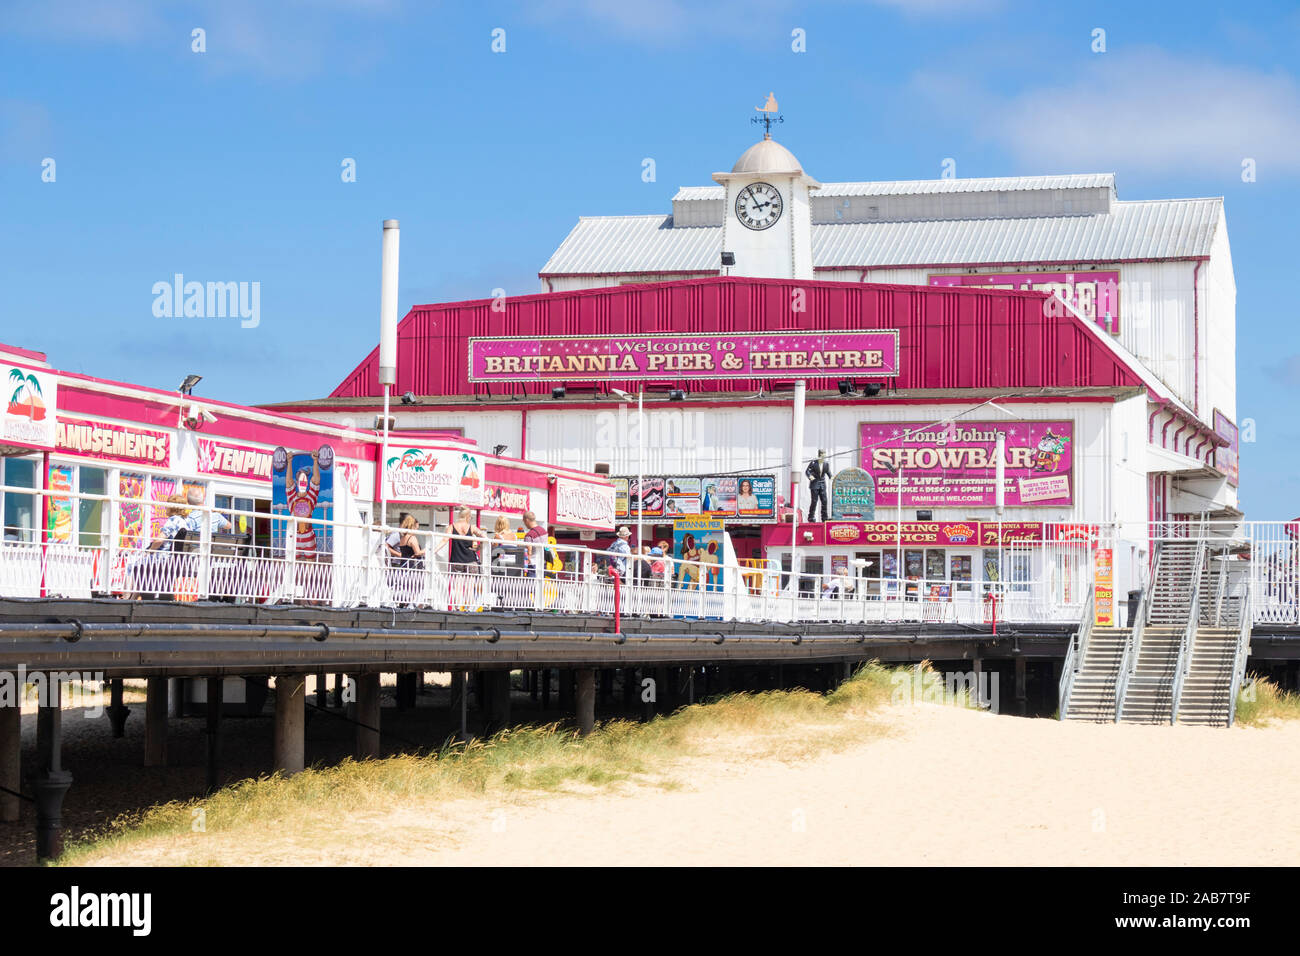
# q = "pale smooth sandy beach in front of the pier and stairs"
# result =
<box><xmin>73</xmin><ymin>705</ymin><xmax>1300</xmax><ymax>866</ymax></box>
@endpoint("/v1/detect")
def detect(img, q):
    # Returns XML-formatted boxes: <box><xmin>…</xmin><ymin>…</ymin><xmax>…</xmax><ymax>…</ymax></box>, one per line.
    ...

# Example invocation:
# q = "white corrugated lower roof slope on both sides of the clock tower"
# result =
<box><xmin>541</xmin><ymin>199</ymin><xmax>1223</xmax><ymax>276</ymax></box>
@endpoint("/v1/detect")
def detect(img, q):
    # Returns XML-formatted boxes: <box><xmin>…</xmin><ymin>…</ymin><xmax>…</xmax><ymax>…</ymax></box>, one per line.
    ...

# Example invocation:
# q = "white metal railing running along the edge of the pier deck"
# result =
<box><xmin>0</xmin><ymin>486</ymin><xmax>1300</xmax><ymax>629</ymax></box>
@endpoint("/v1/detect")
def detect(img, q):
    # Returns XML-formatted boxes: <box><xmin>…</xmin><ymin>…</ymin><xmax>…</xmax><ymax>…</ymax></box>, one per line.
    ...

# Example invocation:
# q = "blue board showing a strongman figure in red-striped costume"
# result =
<box><xmin>270</xmin><ymin>445</ymin><xmax>335</xmax><ymax>561</ymax></box>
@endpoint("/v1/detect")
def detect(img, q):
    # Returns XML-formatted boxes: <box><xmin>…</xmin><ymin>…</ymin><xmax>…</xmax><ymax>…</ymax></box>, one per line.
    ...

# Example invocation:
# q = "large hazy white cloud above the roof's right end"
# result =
<box><xmin>946</xmin><ymin>49</ymin><xmax>1300</xmax><ymax>178</ymax></box>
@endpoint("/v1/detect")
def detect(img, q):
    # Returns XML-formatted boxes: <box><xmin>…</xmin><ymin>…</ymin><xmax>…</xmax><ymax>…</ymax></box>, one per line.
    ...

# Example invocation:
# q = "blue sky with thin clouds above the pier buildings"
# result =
<box><xmin>0</xmin><ymin>0</ymin><xmax>1300</xmax><ymax>518</ymax></box>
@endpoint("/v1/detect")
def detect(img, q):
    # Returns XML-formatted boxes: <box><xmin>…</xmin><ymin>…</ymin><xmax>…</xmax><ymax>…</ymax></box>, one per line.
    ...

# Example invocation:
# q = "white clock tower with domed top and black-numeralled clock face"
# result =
<box><xmin>714</xmin><ymin>133</ymin><xmax>822</xmax><ymax>278</ymax></box>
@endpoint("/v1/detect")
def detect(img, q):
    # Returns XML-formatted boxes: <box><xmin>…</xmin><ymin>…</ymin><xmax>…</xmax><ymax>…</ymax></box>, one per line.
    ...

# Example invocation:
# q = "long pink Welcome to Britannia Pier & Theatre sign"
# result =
<box><xmin>469</xmin><ymin>329</ymin><xmax>898</xmax><ymax>382</ymax></box>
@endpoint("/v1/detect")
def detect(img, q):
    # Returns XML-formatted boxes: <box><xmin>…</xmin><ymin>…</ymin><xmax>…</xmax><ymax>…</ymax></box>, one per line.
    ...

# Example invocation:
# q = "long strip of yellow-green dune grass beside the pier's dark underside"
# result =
<box><xmin>60</xmin><ymin>662</ymin><xmax>943</xmax><ymax>865</ymax></box>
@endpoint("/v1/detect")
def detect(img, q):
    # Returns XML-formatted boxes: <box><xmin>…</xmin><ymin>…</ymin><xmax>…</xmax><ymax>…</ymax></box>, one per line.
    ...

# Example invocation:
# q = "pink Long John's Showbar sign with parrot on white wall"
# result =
<box><xmin>858</xmin><ymin>421</ymin><xmax>1074</xmax><ymax>509</ymax></box>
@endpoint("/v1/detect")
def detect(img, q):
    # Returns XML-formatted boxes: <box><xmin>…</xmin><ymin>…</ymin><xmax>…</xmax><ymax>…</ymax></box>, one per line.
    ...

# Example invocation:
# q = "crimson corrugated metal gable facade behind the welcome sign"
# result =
<box><xmin>332</xmin><ymin>277</ymin><xmax>1141</xmax><ymax>398</ymax></box>
